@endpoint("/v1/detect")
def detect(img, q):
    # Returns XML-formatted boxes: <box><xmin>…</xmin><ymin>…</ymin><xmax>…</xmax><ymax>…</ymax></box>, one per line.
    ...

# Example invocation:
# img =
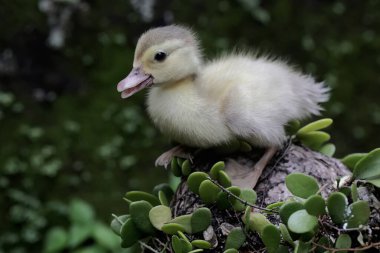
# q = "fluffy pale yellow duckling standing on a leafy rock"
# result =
<box><xmin>117</xmin><ymin>25</ymin><xmax>329</xmax><ymax>188</ymax></box>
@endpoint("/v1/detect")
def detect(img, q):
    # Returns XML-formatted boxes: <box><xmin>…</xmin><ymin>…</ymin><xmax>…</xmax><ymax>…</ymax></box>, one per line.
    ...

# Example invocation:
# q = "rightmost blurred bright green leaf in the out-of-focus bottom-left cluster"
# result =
<box><xmin>93</xmin><ymin>222</ymin><xmax>120</xmax><ymax>250</ymax></box>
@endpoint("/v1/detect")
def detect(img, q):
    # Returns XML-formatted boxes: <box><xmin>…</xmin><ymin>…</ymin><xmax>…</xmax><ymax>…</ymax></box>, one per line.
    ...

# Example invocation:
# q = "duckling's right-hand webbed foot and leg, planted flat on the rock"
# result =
<box><xmin>226</xmin><ymin>147</ymin><xmax>277</xmax><ymax>189</ymax></box>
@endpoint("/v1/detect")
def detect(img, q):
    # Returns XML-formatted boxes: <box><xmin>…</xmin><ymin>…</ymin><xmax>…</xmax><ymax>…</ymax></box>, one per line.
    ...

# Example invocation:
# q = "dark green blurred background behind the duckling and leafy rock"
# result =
<box><xmin>0</xmin><ymin>0</ymin><xmax>380</xmax><ymax>253</ymax></box>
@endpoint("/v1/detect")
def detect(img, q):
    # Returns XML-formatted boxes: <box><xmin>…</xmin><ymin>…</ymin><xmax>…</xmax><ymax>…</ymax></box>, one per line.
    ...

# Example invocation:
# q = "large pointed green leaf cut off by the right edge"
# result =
<box><xmin>352</xmin><ymin>148</ymin><xmax>380</xmax><ymax>180</ymax></box>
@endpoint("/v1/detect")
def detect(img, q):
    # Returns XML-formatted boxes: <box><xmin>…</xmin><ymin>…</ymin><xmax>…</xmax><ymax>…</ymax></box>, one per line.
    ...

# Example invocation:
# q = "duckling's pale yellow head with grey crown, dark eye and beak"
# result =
<box><xmin>117</xmin><ymin>25</ymin><xmax>202</xmax><ymax>98</ymax></box>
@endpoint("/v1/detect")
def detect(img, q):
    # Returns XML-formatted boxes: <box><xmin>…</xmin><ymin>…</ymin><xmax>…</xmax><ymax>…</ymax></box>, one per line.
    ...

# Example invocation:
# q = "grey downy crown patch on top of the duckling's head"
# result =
<box><xmin>135</xmin><ymin>25</ymin><xmax>198</xmax><ymax>59</ymax></box>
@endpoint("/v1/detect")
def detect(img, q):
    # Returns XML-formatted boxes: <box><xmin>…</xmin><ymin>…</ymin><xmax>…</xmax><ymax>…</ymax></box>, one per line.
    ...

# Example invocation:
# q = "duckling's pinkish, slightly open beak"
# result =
<box><xmin>117</xmin><ymin>68</ymin><xmax>153</xmax><ymax>98</ymax></box>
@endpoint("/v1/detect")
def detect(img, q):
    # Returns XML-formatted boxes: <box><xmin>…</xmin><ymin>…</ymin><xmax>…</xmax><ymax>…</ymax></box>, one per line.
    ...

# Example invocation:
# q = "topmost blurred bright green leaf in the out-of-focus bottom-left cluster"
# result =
<box><xmin>69</xmin><ymin>199</ymin><xmax>95</xmax><ymax>224</ymax></box>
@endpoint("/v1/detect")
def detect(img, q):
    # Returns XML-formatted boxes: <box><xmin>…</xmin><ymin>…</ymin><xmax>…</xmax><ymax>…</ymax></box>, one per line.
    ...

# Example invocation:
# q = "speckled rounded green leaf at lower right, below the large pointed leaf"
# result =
<box><xmin>347</xmin><ymin>200</ymin><xmax>371</xmax><ymax>228</ymax></box>
